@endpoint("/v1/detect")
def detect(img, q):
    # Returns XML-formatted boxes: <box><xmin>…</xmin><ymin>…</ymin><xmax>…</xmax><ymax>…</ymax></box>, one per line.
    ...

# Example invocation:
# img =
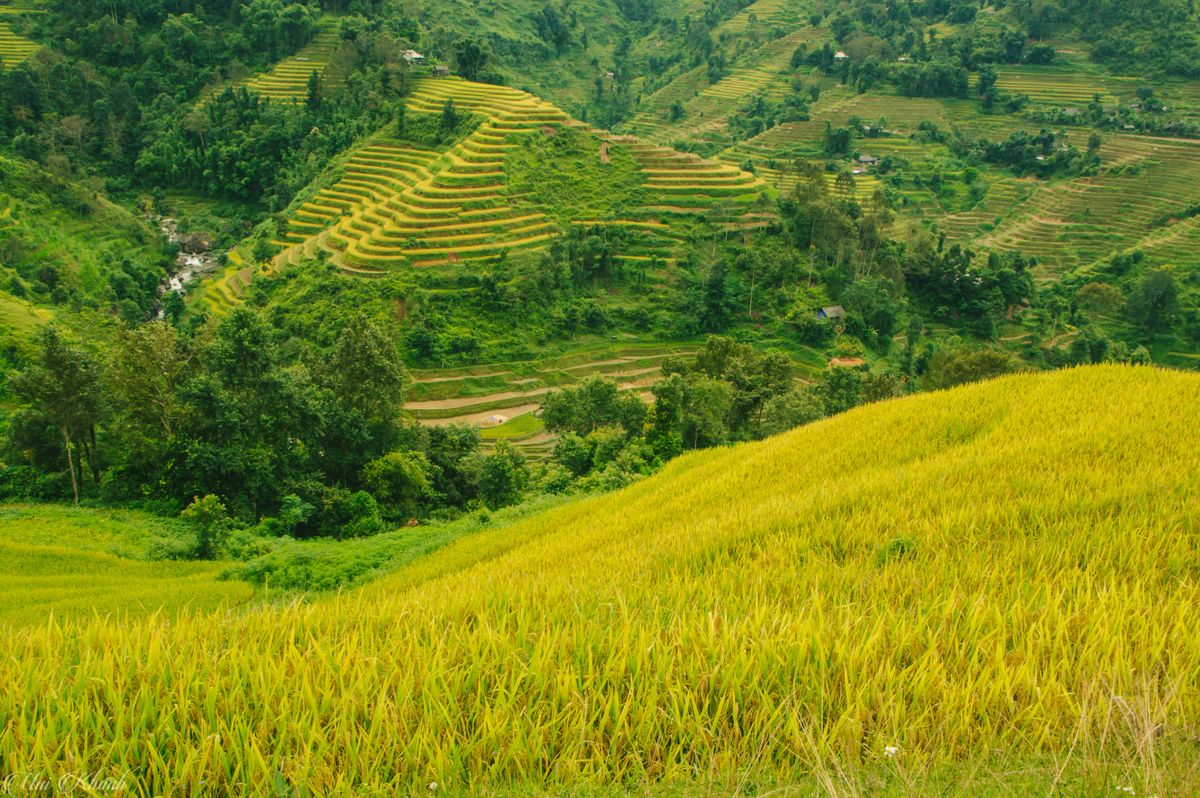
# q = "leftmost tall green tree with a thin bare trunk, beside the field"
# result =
<box><xmin>10</xmin><ymin>324</ymin><xmax>102</xmax><ymax>504</ymax></box>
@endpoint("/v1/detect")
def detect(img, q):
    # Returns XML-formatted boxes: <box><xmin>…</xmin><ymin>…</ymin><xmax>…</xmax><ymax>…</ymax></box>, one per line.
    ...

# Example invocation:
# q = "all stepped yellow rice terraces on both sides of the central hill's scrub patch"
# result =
<box><xmin>267</xmin><ymin>77</ymin><xmax>763</xmax><ymax>276</ymax></box>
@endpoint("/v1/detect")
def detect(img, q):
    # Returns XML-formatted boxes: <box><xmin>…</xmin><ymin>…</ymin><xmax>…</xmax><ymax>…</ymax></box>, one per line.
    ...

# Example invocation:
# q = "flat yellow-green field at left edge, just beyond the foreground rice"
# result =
<box><xmin>0</xmin><ymin>505</ymin><xmax>251</xmax><ymax>626</ymax></box>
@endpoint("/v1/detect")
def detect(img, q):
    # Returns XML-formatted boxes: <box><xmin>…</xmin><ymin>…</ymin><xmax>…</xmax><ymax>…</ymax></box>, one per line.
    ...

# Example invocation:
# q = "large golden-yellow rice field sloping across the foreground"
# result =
<box><xmin>0</xmin><ymin>367</ymin><xmax>1200</xmax><ymax>796</ymax></box>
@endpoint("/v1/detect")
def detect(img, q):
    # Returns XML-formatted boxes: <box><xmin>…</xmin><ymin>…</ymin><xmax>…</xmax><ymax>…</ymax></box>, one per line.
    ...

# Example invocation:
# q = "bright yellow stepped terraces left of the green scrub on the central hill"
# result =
<box><xmin>283</xmin><ymin>78</ymin><xmax>568</xmax><ymax>275</ymax></box>
